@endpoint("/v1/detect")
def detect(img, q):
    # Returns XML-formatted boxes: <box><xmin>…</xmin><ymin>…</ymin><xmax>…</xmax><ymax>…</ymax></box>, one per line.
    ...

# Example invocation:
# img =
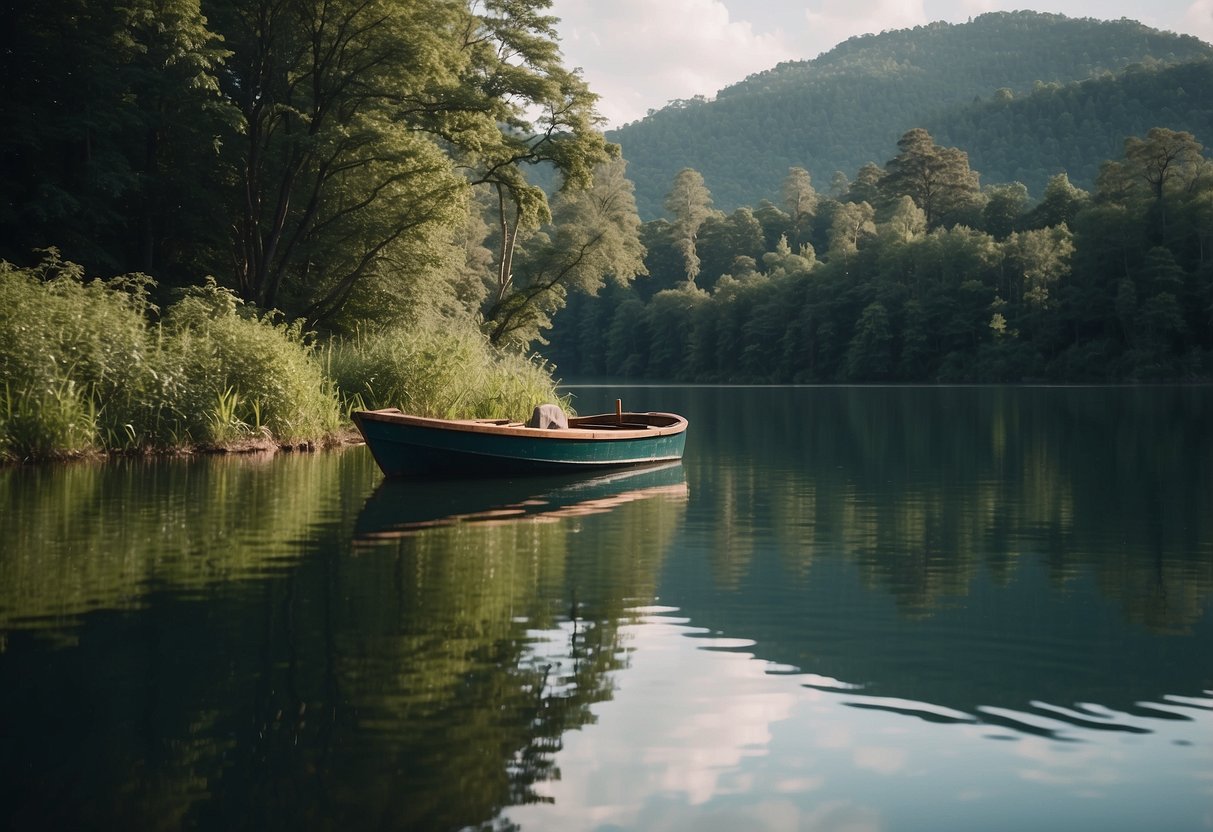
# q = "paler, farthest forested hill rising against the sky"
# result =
<box><xmin>608</xmin><ymin>12</ymin><xmax>1213</xmax><ymax>220</ymax></box>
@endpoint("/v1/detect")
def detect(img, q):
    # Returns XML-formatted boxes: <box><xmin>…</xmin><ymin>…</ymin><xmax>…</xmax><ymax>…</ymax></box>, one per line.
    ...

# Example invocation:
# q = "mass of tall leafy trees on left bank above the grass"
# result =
<box><xmin>0</xmin><ymin>0</ymin><xmax>619</xmax><ymax>330</ymax></box>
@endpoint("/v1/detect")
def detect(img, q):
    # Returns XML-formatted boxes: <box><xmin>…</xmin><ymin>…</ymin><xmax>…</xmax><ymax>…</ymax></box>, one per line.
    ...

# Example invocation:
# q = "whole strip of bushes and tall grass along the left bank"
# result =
<box><xmin>0</xmin><ymin>252</ymin><xmax>565</xmax><ymax>461</ymax></box>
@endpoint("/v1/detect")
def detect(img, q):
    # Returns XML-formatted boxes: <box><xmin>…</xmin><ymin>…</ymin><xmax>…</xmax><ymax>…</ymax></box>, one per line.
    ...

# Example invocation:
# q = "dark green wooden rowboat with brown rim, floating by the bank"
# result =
<box><xmin>353</xmin><ymin>403</ymin><xmax>687</xmax><ymax>477</ymax></box>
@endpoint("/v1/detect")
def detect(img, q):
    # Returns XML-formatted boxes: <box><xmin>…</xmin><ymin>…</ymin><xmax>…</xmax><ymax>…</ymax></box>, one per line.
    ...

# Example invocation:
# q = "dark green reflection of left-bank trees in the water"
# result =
<box><xmin>0</xmin><ymin>450</ymin><xmax>687</xmax><ymax>830</ymax></box>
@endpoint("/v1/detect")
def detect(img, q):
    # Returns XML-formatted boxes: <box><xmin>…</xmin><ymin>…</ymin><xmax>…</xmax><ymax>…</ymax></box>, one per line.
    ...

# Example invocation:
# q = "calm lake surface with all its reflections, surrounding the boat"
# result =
<box><xmin>0</xmin><ymin>387</ymin><xmax>1213</xmax><ymax>832</ymax></box>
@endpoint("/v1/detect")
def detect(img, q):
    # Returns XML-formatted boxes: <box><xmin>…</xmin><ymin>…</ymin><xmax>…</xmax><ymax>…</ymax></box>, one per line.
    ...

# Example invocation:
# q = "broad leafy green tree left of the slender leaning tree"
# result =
<box><xmin>213</xmin><ymin>0</ymin><xmax>467</xmax><ymax>323</ymax></box>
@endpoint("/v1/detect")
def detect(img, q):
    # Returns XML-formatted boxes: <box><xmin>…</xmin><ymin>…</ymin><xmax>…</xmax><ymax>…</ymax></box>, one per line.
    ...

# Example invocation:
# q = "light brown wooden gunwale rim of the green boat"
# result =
<box><xmin>353</xmin><ymin>408</ymin><xmax>688</xmax><ymax>441</ymax></box>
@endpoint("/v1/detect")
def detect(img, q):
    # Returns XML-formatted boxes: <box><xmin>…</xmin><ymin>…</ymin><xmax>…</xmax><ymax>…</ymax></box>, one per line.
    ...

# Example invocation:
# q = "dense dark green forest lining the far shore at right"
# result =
<box><xmin>549</xmin><ymin>127</ymin><xmax>1213</xmax><ymax>383</ymax></box>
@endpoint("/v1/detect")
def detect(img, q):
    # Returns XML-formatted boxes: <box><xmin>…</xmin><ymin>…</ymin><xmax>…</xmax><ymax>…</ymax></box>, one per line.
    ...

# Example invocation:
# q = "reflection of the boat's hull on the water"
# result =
<box><xmin>353</xmin><ymin>462</ymin><xmax>690</xmax><ymax>547</ymax></box>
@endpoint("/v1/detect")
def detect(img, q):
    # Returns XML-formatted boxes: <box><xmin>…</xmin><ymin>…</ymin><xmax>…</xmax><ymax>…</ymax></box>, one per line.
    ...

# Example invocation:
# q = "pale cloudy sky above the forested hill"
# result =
<box><xmin>551</xmin><ymin>0</ymin><xmax>1213</xmax><ymax>127</ymax></box>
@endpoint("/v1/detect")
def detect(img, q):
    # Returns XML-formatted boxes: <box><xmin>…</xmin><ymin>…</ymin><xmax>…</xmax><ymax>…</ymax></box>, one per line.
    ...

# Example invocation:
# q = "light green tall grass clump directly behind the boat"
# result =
<box><xmin>326</xmin><ymin>324</ymin><xmax>569</xmax><ymax>418</ymax></box>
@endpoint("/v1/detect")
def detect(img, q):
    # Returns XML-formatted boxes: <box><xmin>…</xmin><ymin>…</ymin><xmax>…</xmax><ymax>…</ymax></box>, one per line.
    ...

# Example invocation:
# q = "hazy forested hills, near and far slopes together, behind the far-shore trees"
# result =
<box><xmin>608</xmin><ymin>12</ymin><xmax>1213</xmax><ymax>220</ymax></box>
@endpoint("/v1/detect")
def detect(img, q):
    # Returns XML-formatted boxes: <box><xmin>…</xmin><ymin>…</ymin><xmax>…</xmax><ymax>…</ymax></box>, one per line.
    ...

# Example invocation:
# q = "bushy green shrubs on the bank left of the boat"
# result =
<box><xmin>0</xmin><ymin>251</ymin><xmax>340</xmax><ymax>458</ymax></box>
